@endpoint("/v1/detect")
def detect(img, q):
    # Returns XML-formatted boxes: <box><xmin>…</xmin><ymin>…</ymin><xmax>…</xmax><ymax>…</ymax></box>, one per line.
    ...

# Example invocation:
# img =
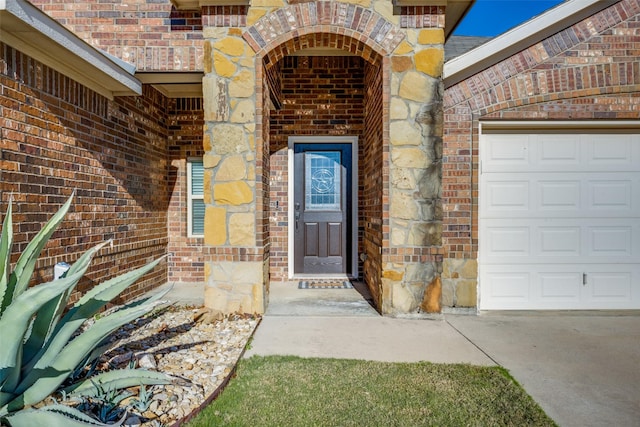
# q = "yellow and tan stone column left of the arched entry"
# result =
<box><xmin>203</xmin><ymin>27</ymin><xmax>266</xmax><ymax>313</ymax></box>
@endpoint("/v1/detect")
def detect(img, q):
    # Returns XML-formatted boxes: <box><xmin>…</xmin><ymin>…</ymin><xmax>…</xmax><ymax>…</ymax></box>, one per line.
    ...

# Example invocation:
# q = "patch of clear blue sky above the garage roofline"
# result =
<box><xmin>454</xmin><ymin>0</ymin><xmax>562</xmax><ymax>36</ymax></box>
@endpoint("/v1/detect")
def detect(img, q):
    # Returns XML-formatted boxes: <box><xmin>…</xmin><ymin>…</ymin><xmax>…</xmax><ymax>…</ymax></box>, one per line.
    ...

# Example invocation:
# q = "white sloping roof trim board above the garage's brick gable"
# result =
<box><xmin>443</xmin><ymin>0</ymin><xmax>619</xmax><ymax>87</ymax></box>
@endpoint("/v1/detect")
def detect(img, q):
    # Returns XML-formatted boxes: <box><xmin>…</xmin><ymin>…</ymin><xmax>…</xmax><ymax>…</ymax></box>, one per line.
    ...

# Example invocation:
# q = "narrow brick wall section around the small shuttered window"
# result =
<box><xmin>167</xmin><ymin>98</ymin><xmax>204</xmax><ymax>283</ymax></box>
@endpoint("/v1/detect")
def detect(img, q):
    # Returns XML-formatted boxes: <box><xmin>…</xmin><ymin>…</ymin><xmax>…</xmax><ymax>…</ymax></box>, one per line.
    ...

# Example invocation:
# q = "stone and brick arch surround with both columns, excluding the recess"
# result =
<box><xmin>202</xmin><ymin>0</ymin><xmax>445</xmax><ymax>314</ymax></box>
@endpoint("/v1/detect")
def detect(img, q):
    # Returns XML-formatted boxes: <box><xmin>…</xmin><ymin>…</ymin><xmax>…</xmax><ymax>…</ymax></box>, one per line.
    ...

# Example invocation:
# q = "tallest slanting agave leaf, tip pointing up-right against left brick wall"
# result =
<box><xmin>5</xmin><ymin>194</ymin><xmax>73</xmax><ymax>301</ymax></box>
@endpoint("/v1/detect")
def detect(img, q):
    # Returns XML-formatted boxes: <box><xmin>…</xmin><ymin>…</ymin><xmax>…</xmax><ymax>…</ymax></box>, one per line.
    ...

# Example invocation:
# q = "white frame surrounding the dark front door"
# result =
<box><xmin>287</xmin><ymin>135</ymin><xmax>359</xmax><ymax>279</ymax></box>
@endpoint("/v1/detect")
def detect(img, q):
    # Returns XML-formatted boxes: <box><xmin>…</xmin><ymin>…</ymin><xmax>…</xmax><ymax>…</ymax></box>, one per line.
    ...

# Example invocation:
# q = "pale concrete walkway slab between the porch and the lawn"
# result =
<box><xmin>245</xmin><ymin>315</ymin><xmax>494</xmax><ymax>365</ymax></box>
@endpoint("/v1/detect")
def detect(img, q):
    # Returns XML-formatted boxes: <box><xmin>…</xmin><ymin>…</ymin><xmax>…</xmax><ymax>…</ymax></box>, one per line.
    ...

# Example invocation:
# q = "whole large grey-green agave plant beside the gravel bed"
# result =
<box><xmin>0</xmin><ymin>195</ymin><xmax>170</xmax><ymax>427</ymax></box>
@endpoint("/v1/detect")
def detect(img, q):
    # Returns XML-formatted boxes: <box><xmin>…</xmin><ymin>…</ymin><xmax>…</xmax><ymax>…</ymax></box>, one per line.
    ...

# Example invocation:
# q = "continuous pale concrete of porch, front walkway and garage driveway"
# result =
<box><xmin>245</xmin><ymin>284</ymin><xmax>640</xmax><ymax>427</ymax></box>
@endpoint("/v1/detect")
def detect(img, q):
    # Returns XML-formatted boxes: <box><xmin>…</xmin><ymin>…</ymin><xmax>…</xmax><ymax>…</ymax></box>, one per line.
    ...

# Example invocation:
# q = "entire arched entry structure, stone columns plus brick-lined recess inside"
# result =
<box><xmin>203</xmin><ymin>1</ymin><xmax>444</xmax><ymax>314</ymax></box>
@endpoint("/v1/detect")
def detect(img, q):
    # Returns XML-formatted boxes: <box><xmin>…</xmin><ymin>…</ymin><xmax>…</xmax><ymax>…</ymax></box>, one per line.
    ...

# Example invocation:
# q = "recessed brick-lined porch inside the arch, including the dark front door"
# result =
<box><xmin>255</xmin><ymin>33</ymin><xmax>388</xmax><ymax>304</ymax></box>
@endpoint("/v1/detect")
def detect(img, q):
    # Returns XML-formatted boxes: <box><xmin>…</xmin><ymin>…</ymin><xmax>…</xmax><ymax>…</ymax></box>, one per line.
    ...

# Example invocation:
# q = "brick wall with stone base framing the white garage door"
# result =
<box><xmin>442</xmin><ymin>0</ymin><xmax>640</xmax><ymax>307</ymax></box>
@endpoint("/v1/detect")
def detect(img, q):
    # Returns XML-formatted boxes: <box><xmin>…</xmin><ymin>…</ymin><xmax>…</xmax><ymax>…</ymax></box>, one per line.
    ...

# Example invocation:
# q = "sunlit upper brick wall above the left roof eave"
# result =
<box><xmin>31</xmin><ymin>0</ymin><xmax>203</xmax><ymax>71</ymax></box>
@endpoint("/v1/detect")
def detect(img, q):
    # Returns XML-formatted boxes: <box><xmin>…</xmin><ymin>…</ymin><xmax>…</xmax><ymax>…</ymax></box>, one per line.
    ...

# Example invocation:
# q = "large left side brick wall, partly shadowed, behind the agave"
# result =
<box><xmin>0</xmin><ymin>44</ymin><xmax>169</xmax><ymax>304</ymax></box>
